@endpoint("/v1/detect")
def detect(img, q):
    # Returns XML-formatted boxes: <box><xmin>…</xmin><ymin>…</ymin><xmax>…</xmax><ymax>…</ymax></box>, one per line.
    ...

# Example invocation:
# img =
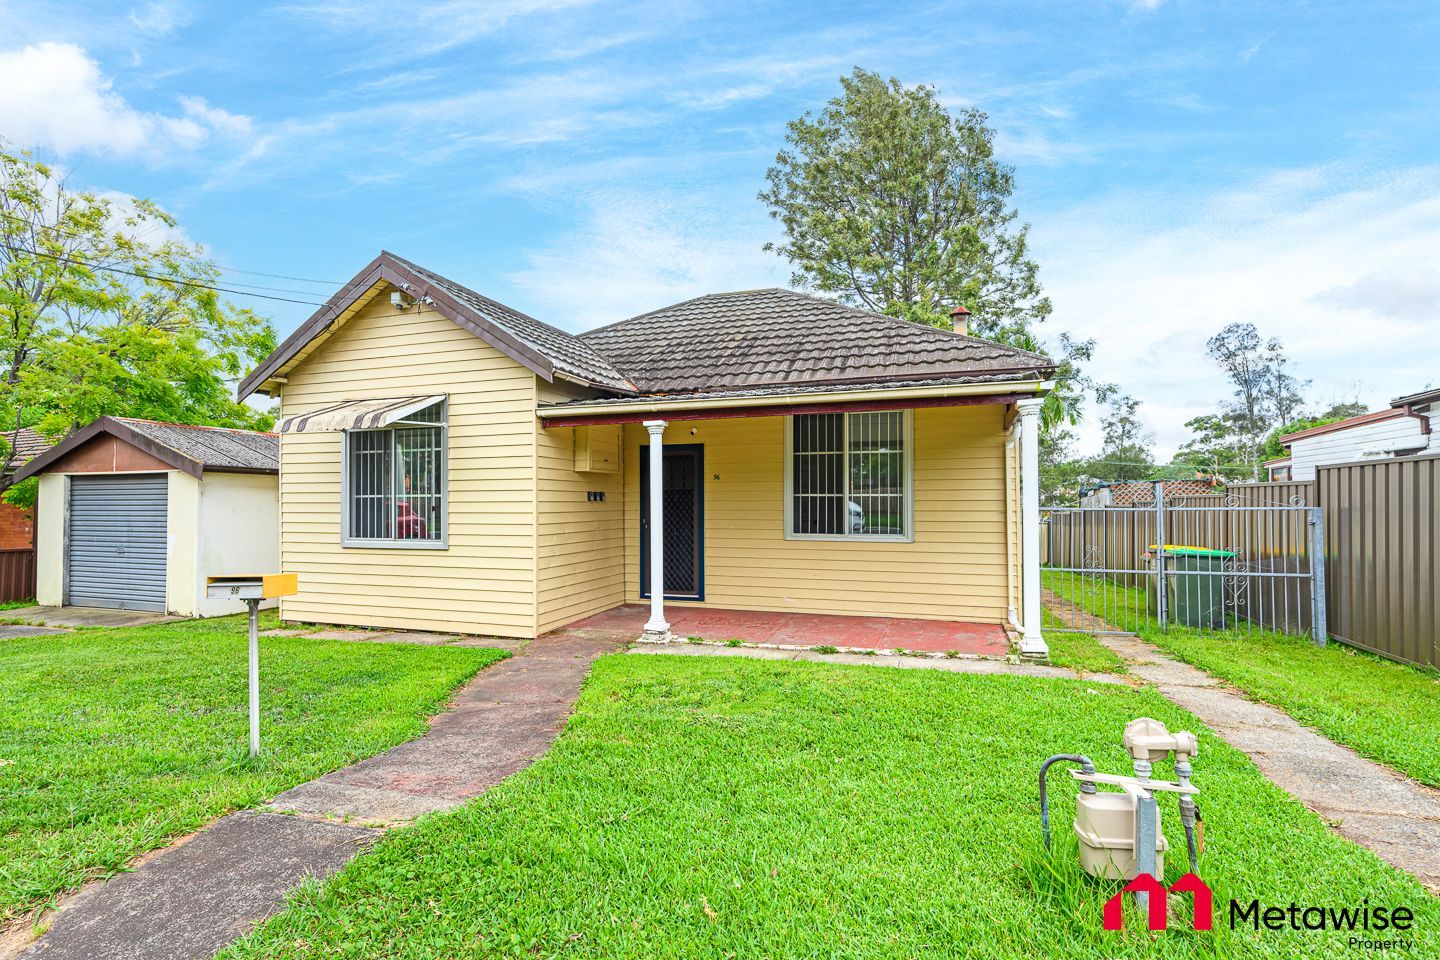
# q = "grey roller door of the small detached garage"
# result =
<box><xmin>65</xmin><ymin>474</ymin><xmax>168</xmax><ymax>613</ymax></box>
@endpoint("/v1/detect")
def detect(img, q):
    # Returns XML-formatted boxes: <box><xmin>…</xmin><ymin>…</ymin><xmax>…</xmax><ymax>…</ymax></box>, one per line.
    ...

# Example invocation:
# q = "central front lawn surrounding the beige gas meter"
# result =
<box><xmin>222</xmin><ymin>655</ymin><xmax>1440</xmax><ymax>960</ymax></box>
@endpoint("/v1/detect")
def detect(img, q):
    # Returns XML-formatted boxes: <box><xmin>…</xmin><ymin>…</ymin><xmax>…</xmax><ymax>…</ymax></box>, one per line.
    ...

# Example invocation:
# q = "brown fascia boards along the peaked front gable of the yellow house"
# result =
<box><xmin>236</xmin><ymin>253</ymin><xmax>554</xmax><ymax>400</ymax></box>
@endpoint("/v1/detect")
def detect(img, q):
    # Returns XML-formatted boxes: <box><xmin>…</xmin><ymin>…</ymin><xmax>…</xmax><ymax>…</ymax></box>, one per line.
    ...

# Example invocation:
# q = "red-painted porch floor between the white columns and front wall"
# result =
<box><xmin>563</xmin><ymin>604</ymin><xmax>1009</xmax><ymax>658</ymax></box>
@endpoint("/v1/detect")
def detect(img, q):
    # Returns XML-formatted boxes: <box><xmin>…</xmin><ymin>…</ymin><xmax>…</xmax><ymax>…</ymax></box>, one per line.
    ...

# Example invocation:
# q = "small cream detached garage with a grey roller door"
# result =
<box><xmin>16</xmin><ymin>417</ymin><xmax>279</xmax><ymax>616</ymax></box>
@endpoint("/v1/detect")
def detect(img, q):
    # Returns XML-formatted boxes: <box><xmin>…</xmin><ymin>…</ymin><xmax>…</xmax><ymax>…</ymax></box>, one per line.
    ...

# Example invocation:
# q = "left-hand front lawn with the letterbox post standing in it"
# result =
<box><xmin>0</xmin><ymin>617</ymin><xmax>505</xmax><ymax>921</ymax></box>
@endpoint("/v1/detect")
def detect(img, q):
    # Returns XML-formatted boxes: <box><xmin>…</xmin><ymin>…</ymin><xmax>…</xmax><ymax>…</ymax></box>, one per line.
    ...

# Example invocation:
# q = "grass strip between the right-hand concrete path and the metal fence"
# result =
<box><xmin>1047</xmin><ymin>577</ymin><xmax>1440</xmax><ymax>786</ymax></box>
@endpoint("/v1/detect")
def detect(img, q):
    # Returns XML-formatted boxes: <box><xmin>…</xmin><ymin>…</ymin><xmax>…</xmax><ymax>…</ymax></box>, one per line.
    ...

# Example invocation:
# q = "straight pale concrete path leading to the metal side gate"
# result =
<box><xmin>1100</xmin><ymin>636</ymin><xmax>1440</xmax><ymax>892</ymax></box>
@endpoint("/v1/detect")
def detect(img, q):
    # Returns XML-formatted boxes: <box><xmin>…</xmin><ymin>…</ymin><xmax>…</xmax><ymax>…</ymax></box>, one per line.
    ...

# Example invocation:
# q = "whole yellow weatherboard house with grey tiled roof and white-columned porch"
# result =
<box><xmin>239</xmin><ymin>253</ymin><xmax>1054</xmax><ymax>655</ymax></box>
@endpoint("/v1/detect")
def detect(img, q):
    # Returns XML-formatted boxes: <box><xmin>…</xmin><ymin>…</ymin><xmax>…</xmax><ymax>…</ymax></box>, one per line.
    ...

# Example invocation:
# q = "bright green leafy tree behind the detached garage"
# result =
<box><xmin>0</xmin><ymin>147</ymin><xmax>275</xmax><ymax>499</ymax></box>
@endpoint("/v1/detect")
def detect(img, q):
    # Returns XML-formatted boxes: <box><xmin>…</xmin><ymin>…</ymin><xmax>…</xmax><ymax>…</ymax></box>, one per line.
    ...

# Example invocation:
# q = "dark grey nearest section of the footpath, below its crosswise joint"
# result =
<box><xmin>22</xmin><ymin>813</ymin><xmax>379</xmax><ymax>960</ymax></box>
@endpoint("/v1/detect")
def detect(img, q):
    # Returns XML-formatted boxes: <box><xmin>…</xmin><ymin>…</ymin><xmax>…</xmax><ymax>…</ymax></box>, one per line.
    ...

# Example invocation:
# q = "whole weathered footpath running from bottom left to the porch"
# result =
<box><xmin>14</xmin><ymin>630</ymin><xmax>634</xmax><ymax>960</ymax></box>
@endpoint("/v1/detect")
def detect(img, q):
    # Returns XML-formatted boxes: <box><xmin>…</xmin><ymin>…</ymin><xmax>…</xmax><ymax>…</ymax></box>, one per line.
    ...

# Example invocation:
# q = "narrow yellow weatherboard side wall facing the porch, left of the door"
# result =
<box><xmin>534</xmin><ymin>379</ymin><xmax>625</xmax><ymax>633</ymax></box>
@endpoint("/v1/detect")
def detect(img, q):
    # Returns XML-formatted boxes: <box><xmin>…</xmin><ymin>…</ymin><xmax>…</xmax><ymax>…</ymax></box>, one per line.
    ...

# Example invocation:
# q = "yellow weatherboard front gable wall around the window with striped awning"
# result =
<box><xmin>279</xmin><ymin>291</ymin><xmax>537</xmax><ymax>636</ymax></box>
